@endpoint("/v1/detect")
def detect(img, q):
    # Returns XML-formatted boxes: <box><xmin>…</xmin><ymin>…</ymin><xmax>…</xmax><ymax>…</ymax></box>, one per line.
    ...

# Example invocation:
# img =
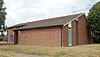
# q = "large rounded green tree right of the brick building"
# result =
<box><xmin>87</xmin><ymin>1</ymin><xmax>100</xmax><ymax>43</ymax></box>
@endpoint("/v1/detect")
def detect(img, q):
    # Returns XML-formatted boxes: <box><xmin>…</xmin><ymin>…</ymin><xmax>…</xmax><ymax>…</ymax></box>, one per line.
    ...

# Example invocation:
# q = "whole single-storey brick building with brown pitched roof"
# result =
<box><xmin>7</xmin><ymin>13</ymin><xmax>89</xmax><ymax>46</ymax></box>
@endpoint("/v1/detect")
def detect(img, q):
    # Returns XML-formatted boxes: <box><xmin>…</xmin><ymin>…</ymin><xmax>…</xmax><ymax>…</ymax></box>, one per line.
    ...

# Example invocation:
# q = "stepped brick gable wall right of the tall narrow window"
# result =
<box><xmin>72</xmin><ymin>15</ymin><xmax>88</xmax><ymax>45</ymax></box>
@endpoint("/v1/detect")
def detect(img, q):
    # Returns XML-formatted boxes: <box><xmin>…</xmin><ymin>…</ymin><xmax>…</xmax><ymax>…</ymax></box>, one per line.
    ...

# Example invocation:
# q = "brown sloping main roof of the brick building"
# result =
<box><xmin>12</xmin><ymin>13</ymin><xmax>84</xmax><ymax>30</ymax></box>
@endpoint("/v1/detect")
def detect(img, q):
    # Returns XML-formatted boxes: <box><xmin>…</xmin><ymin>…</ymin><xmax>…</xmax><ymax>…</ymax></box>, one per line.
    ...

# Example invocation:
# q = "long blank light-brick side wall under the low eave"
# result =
<box><xmin>18</xmin><ymin>28</ymin><xmax>61</xmax><ymax>46</ymax></box>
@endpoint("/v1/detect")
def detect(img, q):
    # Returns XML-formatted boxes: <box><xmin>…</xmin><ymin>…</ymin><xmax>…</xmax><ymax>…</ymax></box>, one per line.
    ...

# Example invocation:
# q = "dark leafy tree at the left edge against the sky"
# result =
<box><xmin>0</xmin><ymin>0</ymin><xmax>6</xmax><ymax>36</ymax></box>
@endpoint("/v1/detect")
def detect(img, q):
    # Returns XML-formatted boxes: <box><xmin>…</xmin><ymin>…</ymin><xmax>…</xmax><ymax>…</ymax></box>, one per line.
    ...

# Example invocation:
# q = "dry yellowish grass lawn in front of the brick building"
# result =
<box><xmin>0</xmin><ymin>44</ymin><xmax>100</xmax><ymax>57</ymax></box>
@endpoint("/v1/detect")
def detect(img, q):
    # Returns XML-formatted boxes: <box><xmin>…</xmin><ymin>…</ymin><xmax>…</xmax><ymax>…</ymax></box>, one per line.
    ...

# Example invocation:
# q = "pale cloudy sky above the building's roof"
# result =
<box><xmin>4</xmin><ymin>0</ymin><xmax>100</xmax><ymax>27</ymax></box>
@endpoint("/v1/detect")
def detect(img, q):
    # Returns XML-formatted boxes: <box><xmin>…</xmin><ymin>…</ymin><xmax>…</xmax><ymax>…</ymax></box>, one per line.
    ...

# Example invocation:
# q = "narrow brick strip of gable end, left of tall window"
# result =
<box><xmin>62</xmin><ymin>25</ymin><xmax>68</xmax><ymax>46</ymax></box>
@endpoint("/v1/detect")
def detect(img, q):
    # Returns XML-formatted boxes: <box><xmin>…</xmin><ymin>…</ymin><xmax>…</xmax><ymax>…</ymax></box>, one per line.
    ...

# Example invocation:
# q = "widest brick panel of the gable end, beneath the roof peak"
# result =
<box><xmin>77</xmin><ymin>16</ymin><xmax>88</xmax><ymax>44</ymax></box>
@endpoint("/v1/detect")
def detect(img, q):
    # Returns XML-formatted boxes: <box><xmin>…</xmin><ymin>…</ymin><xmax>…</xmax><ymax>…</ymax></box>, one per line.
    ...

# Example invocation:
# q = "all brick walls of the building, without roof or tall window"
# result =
<box><xmin>8</xmin><ymin>15</ymin><xmax>88</xmax><ymax>47</ymax></box>
